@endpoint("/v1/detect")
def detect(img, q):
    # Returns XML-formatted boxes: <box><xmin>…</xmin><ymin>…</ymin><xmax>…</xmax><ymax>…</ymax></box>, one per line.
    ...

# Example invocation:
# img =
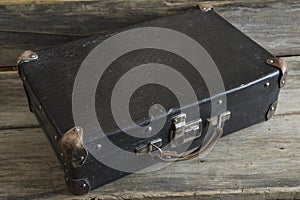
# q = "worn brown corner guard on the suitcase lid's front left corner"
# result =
<box><xmin>59</xmin><ymin>126</ymin><xmax>88</xmax><ymax>167</ymax></box>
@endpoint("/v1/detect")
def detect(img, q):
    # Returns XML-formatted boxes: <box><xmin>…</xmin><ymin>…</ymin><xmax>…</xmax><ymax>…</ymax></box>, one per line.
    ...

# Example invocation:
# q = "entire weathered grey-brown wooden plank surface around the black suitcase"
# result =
<box><xmin>0</xmin><ymin>0</ymin><xmax>300</xmax><ymax>200</ymax></box>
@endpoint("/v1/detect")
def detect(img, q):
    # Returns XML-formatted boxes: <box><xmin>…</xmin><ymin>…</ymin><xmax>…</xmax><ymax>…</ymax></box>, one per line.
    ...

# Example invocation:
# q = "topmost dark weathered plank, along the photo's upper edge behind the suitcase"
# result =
<box><xmin>0</xmin><ymin>0</ymin><xmax>299</xmax><ymax>35</ymax></box>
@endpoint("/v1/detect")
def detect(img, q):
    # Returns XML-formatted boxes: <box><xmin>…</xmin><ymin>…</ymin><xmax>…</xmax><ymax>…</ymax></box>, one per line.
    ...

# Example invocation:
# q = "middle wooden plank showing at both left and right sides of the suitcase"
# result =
<box><xmin>0</xmin><ymin>57</ymin><xmax>300</xmax><ymax>129</ymax></box>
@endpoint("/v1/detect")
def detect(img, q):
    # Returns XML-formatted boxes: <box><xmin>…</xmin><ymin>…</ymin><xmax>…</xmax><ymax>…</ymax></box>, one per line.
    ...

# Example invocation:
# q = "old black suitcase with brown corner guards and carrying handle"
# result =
<box><xmin>18</xmin><ymin>4</ymin><xmax>287</xmax><ymax>194</ymax></box>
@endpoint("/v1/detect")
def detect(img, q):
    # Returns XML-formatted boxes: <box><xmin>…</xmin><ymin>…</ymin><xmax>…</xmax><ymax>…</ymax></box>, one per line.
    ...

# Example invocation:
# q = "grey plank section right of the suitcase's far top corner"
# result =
<box><xmin>220</xmin><ymin>1</ymin><xmax>300</xmax><ymax>56</ymax></box>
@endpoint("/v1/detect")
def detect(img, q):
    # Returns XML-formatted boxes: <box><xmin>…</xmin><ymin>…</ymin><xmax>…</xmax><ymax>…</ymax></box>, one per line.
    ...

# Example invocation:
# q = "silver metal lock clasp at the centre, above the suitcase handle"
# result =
<box><xmin>170</xmin><ymin>113</ymin><xmax>202</xmax><ymax>147</ymax></box>
